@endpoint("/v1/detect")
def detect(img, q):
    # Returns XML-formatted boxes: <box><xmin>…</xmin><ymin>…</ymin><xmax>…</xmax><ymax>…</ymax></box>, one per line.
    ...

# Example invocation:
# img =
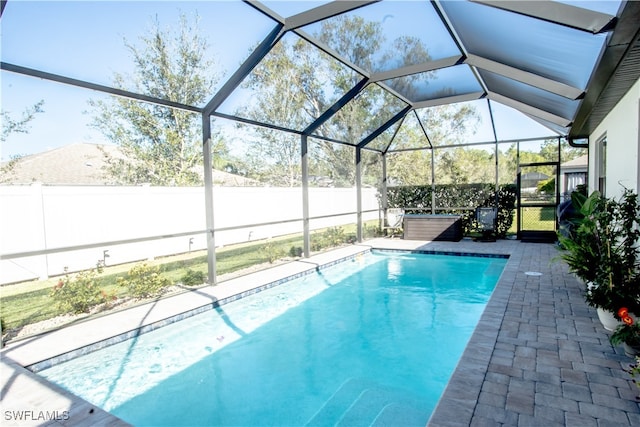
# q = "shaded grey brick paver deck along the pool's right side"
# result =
<box><xmin>429</xmin><ymin>243</ymin><xmax>640</xmax><ymax>427</ymax></box>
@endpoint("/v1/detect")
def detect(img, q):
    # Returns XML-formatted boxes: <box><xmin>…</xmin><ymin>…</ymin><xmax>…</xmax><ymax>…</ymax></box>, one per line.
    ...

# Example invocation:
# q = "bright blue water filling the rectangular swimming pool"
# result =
<box><xmin>39</xmin><ymin>252</ymin><xmax>506</xmax><ymax>426</ymax></box>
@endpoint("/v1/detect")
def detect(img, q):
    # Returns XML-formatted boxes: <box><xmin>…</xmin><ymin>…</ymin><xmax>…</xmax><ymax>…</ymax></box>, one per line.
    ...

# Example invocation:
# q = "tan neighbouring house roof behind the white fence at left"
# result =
<box><xmin>0</xmin><ymin>143</ymin><xmax>261</xmax><ymax>187</ymax></box>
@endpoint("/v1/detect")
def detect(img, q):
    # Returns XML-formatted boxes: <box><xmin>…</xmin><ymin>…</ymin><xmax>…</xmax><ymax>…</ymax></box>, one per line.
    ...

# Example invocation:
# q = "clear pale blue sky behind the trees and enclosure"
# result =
<box><xmin>0</xmin><ymin>0</ymin><xmax>568</xmax><ymax>161</ymax></box>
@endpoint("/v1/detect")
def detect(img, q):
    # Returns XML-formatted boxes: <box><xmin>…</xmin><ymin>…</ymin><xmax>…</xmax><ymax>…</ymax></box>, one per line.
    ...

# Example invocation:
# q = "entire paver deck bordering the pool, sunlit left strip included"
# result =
<box><xmin>0</xmin><ymin>239</ymin><xmax>640</xmax><ymax>427</ymax></box>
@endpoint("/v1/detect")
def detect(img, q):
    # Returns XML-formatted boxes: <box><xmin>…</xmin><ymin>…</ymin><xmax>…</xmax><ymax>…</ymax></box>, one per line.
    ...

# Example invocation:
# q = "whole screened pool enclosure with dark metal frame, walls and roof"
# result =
<box><xmin>1</xmin><ymin>1</ymin><xmax>638</xmax><ymax>283</ymax></box>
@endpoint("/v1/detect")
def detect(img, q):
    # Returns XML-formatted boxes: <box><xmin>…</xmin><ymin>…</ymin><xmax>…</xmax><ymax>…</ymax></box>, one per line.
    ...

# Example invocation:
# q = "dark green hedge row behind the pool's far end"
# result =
<box><xmin>387</xmin><ymin>184</ymin><xmax>516</xmax><ymax>238</ymax></box>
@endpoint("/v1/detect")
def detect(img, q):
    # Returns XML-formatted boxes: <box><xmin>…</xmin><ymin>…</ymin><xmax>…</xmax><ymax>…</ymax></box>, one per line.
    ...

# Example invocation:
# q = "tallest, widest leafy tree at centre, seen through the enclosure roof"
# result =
<box><xmin>238</xmin><ymin>16</ymin><xmax>480</xmax><ymax>186</ymax></box>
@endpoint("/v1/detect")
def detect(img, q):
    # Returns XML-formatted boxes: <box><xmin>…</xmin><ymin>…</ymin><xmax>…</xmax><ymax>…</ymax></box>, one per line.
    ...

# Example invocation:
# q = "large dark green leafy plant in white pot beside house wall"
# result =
<box><xmin>558</xmin><ymin>188</ymin><xmax>640</xmax><ymax>330</ymax></box>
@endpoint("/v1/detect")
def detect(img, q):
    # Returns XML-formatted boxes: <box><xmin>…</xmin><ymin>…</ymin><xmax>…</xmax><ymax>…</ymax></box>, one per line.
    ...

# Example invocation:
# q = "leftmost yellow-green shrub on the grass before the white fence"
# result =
<box><xmin>51</xmin><ymin>265</ymin><xmax>110</xmax><ymax>314</ymax></box>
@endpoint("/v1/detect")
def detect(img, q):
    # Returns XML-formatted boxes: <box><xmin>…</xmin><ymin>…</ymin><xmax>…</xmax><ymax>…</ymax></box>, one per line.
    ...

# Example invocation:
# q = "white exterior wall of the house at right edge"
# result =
<box><xmin>589</xmin><ymin>80</ymin><xmax>640</xmax><ymax>197</ymax></box>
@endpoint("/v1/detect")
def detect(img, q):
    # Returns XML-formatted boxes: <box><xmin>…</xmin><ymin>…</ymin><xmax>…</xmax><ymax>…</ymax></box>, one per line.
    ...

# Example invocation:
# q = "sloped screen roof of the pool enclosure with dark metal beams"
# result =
<box><xmin>2</xmin><ymin>0</ymin><xmax>640</xmax><ymax>152</ymax></box>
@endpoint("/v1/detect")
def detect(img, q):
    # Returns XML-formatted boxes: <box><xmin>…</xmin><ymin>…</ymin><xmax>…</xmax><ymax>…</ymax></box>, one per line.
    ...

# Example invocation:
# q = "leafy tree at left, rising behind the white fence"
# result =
<box><xmin>90</xmin><ymin>15</ymin><xmax>227</xmax><ymax>185</ymax></box>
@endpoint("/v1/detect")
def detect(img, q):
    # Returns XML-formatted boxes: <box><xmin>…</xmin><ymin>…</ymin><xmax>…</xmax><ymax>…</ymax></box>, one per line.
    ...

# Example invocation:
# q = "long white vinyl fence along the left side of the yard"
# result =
<box><xmin>0</xmin><ymin>184</ymin><xmax>379</xmax><ymax>284</ymax></box>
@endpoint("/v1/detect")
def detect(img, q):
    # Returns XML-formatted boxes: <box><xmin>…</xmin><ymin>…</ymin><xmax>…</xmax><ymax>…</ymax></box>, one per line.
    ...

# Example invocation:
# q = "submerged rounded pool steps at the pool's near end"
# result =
<box><xmin>306</xmin><ymin>378</ymin><xmax>430</xmax><ymax>427</ymax></box>
